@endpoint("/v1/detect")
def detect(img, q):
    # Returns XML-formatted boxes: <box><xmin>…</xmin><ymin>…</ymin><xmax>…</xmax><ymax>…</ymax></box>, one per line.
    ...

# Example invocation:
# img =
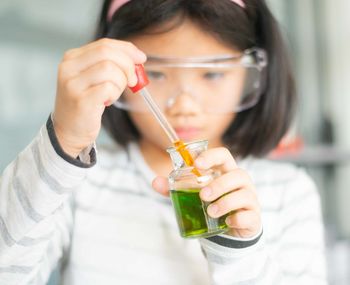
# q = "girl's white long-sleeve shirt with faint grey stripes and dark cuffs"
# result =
<box><xmin>0</xmin><ymin>117</ymin><xmax>327</xmax><ymax>285</ymax></box>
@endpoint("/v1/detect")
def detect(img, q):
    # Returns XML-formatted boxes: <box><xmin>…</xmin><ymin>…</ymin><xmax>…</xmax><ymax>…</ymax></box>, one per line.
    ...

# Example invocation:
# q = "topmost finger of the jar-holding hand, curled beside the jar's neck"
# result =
<box><xmin>195</xmin><ymin>147</ymin><xmax>237</xmax><ymax>172</ymax></box>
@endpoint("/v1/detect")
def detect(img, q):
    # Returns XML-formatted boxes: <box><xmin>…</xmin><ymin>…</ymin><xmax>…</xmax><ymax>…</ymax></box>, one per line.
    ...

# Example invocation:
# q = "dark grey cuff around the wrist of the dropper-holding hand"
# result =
<box><xmin>46</xmin><ymin>115</ymin><xmax>96</xmax><ymax>168</ymax></box>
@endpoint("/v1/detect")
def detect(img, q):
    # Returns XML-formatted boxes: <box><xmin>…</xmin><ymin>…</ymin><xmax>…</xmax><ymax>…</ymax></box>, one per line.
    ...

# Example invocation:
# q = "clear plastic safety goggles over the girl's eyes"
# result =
<box><xmin>114</xmin><ymin>48</ymin><xmax>267</xmax><ymax>113</ymax></box>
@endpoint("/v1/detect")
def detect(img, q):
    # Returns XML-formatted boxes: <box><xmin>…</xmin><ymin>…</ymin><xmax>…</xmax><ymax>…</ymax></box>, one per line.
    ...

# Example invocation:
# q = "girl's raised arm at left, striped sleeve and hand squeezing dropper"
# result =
<box><xmin>0</xmin><ymin>39</ymin><xmax>146</xmax><ymax>284</ymax></box>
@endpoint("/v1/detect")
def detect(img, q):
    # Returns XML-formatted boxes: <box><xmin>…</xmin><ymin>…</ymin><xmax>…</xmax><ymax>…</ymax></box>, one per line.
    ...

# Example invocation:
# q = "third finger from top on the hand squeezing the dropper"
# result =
<box><xmin>67</xmin><ymin>61</ymin><xmax>127</xmax><ymax>95</ymax></box>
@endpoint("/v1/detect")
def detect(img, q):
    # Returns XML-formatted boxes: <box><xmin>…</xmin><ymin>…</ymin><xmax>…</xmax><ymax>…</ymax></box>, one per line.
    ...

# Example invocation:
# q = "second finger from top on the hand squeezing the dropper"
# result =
<box><xmin>63</xmin><ymin>47</ymin><xmax>137</xmax><ymax>86</ymax></box>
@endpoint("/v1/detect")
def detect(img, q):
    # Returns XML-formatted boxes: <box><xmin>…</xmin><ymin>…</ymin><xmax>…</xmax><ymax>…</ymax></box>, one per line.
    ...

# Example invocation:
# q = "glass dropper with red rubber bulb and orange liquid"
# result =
<box><xmin>129</xmin><ymin>64</ymin><xmax>201</xmax><ymax>176</ymax></box>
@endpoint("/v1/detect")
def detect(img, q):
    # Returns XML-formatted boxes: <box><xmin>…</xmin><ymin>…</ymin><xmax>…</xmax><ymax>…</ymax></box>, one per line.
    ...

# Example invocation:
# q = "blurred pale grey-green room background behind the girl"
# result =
<box><xmin>0</xmin><ymin>0</ymin><xmax>350</xmax><ymax>285</ymax></box>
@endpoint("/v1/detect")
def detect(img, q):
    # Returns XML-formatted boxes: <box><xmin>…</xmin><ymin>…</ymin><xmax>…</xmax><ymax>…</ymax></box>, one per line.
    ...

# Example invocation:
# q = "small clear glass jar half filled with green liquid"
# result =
<box><xmin>167</xmin><ymin>140</ymin><xmax>228</xmax><ymax>238</ymax></box>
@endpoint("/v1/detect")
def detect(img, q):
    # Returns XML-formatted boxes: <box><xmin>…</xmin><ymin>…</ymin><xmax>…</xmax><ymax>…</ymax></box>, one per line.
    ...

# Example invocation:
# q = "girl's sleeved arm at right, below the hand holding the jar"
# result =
<box><xmin>201</xmin><ymin>171</ymin><xmax>327</xmax><ymax>285</ymax></box>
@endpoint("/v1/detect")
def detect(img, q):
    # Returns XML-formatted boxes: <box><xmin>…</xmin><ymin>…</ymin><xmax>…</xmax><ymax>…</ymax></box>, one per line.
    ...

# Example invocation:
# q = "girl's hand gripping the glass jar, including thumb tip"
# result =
<box><xmin>152</xmin><ymin>148</ymin><xmax>261</xmax><ymax>238</ymax></box>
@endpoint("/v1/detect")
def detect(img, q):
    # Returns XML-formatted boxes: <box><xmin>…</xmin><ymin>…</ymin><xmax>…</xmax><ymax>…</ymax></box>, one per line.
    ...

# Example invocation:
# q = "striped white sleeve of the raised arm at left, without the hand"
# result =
<box><xmin>0</xmin><ymin>119</ymin><xmax>93</xmax><ymax>285</ymax></box>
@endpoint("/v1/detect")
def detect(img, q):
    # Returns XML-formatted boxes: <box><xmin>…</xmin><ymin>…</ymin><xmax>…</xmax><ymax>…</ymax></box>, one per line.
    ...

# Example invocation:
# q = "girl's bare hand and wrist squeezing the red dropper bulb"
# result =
<box><xmin>53</xmin><ymin>39</ymin><xmax>146</xmax><ymax>157</ymax></box>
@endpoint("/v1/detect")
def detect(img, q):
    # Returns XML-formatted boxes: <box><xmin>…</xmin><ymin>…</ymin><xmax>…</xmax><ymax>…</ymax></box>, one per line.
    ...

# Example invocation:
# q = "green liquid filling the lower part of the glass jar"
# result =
<box><xmin>170</xmin><ymin>189</ymin><xmax>228</xmax><ymax>237</ymax></box>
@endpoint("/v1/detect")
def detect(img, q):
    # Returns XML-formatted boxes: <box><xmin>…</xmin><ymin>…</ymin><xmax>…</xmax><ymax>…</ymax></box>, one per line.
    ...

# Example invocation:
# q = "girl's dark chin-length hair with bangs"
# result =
<box><xmin>97</xmin><ymin>0</ymin><xmax>296</xmax><ymax>157</ymax></box>
